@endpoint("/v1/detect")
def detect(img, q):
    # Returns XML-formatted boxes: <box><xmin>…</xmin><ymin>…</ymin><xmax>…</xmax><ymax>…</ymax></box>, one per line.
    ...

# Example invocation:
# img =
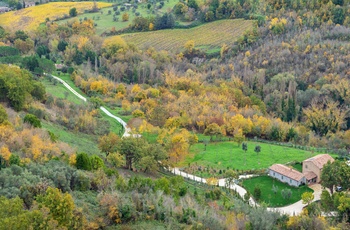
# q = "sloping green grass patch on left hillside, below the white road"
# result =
<box><xmin>41</xmin><ymin>121</ymin><xmax>101</xmax><ymax>154</ymax></box>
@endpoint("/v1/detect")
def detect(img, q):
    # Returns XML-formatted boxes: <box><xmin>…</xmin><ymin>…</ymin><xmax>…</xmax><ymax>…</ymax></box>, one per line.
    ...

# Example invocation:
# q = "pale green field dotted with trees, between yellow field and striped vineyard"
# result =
<box><xmin>58</xmin><ymin>0</ymin><xmax>178</xmax><ymax>34</ymax></box>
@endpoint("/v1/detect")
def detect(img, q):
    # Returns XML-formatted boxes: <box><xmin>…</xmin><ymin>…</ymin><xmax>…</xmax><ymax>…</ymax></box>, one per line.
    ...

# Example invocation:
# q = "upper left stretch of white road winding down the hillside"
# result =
<box><xmin>45</xmin><ymin>74</ymin><xmax>141</xmax><ymax>137</ymax></box>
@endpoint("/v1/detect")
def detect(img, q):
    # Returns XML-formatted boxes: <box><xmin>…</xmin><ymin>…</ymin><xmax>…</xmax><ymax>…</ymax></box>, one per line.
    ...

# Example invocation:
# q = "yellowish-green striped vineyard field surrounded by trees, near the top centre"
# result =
<box><xmin>122</xmin><ymin>19</ymin><xmax>254</xmax><ymax>51</ymax></box>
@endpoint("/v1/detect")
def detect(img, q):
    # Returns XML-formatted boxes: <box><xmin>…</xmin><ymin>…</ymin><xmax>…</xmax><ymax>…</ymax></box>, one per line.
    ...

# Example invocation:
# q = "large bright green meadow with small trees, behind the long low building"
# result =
<box><xmin>180</xmin><ymin>141</ymin><xmax>316</xmax><ymax>170</ymax></box>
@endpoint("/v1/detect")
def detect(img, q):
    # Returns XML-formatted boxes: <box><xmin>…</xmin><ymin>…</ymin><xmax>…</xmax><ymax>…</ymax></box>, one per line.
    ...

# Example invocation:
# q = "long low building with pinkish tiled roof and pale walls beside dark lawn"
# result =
<box><xmin>269</xmin><ymin>164</ymin><xmax>305</xmax><ymax>187</ymax></box>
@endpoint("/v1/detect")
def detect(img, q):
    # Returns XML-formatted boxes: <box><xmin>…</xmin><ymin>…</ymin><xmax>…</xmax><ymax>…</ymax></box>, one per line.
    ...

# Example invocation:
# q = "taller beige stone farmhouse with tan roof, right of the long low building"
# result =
<box><xmin>303</xmin><ymin>154</ymin><xmax>334</xmax><ymax>184</ymax></box>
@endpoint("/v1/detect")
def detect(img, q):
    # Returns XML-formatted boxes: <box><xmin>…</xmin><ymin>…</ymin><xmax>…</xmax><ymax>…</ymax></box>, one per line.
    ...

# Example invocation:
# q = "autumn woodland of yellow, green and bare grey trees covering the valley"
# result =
<box><xmin>0</xmin><ymin>0</ymin><xmax>350</xmax><ymax>229</ymax></box>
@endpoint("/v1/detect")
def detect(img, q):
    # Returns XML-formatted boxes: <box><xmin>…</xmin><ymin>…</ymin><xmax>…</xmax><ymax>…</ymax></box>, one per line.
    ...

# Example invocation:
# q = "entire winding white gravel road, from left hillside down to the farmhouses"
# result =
<box><xmin>45</xmin><ymin>74</ymin><xmax>321</xmax><ymax>216</ymax></box>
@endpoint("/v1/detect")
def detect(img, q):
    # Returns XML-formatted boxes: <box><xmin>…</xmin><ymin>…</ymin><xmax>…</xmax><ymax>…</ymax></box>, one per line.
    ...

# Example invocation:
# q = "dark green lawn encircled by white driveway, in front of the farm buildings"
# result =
<box><xmin>243</xmin><ymin>176</ymin><xmax>313</xmax><ymax>207</ymax></box>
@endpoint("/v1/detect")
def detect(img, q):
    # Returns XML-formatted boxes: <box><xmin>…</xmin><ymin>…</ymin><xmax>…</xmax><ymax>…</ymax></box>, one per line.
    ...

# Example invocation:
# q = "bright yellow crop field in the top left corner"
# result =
<box><xmin>0</xmin><ymin>2</ymin><xmax>112</xmax><ymax>31</ymax></box>
